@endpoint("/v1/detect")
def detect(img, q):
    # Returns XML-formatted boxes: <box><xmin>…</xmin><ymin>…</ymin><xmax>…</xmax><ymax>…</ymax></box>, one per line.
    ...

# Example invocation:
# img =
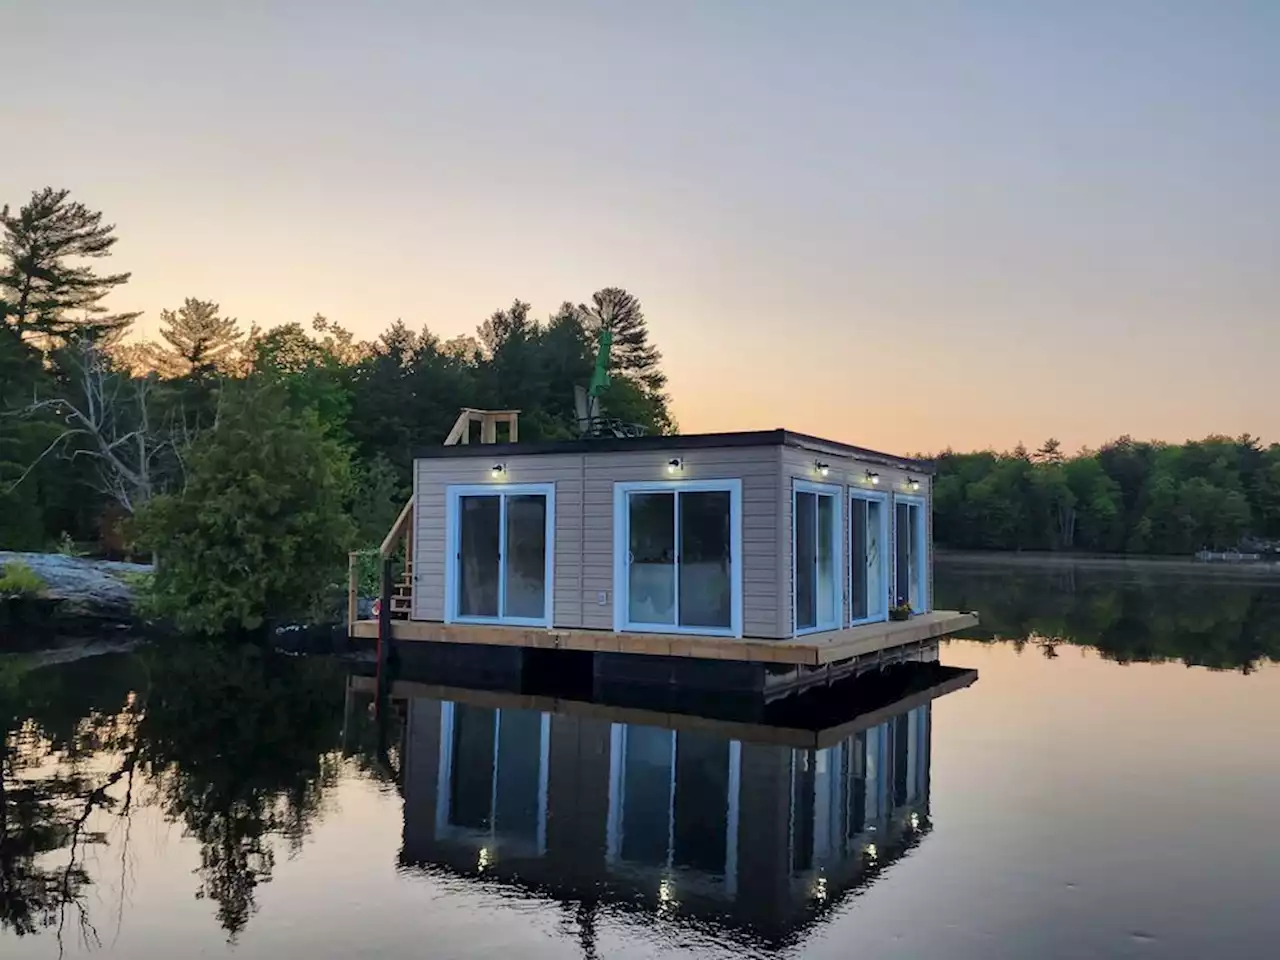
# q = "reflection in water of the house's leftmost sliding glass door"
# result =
<box><xmin>435</xmin><ymin>703</ymin><xmax>550</xmax><ymax>851</ymax></box>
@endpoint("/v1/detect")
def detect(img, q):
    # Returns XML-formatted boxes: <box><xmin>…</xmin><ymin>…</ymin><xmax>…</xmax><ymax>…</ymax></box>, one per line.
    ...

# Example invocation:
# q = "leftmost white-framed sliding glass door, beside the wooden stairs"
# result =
<box><xmin>445</xmin><ymin>484</ymin><xmax>556</xmax><ymax>626</ymax></box>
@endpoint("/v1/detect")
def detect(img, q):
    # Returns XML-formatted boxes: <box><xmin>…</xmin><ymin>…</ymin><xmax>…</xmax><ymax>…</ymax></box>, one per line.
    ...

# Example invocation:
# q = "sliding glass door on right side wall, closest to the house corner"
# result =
<box><xmin>791</xmin><ymin>481</ymin><xmax>842</xmax><ymax>634</ymax></box>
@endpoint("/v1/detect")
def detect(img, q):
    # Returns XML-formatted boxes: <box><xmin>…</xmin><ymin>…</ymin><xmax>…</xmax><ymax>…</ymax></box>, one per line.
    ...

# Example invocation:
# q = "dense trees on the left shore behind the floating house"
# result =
<box><xmin>0</xmin><ymin>188</ymin><xmax>676</xmax><ymax>631</ymax></box>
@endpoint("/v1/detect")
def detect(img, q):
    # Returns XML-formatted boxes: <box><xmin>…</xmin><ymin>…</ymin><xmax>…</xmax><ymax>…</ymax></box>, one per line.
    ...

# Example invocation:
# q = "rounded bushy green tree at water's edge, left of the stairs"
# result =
<box><xmin>138</xmin><ymin>380</ymin><xmax>355</xmax><ymax>634</ymax></box>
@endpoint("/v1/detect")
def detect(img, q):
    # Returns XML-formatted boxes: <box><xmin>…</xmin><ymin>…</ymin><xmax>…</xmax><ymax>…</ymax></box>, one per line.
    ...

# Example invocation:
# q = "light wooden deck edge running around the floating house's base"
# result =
<box><xmin>351</xmin><ymin>611</ymin><xmax>978</xmax><ymax>667</ymax></box>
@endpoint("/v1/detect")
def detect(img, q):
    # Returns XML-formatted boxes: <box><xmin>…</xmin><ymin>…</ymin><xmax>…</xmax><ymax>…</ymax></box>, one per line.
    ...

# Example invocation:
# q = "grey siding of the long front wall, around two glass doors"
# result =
<box><xmin>413</xmin><ymin>447</ymin><xmax>790</xmax><ymax>639</ymax></box>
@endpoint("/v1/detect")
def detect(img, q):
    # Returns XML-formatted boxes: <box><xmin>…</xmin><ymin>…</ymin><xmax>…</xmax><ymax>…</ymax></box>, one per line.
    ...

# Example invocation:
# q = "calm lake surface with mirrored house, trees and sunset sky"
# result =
<box><xmin>0</xmin><ymin>564</ymin><xmax>1280</xmax><ymax>960</ymax></box>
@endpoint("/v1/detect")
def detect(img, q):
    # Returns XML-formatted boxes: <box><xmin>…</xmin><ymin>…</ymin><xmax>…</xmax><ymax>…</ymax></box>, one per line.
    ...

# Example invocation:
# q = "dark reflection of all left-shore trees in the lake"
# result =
<box><xmin>0</xmin><ymin>644</ymin><xmax>343</xmax><ymax>946</ymax></box>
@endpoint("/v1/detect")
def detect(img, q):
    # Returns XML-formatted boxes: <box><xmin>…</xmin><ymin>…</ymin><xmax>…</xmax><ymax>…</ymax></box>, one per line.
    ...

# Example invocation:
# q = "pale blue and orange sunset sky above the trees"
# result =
<box><xmin>0</xmin><ymin>0</ymin><xmax>1280</xmax><ymax>452</ymax></box>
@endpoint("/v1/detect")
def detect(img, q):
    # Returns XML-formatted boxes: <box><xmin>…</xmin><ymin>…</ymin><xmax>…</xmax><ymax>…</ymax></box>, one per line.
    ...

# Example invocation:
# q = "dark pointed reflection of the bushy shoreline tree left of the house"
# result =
<box><xmin>140</xmin><ymin>646</ymin><xmax>342</xmax><ymax>938</ymax></box>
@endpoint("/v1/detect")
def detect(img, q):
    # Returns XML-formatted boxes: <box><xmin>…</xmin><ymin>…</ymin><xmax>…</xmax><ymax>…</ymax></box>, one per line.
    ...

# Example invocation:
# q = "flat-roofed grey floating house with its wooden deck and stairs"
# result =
<box><xmin>351</xmin><ymin>424</ymin><xmax>977</xmax><ymax>692</ymax></box>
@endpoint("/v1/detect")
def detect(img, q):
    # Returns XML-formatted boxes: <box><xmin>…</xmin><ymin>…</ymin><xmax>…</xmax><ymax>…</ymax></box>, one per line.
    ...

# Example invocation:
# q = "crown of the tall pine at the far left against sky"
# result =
<box><xmin>0</xmin><ymin>187</ymin><xmax>140</xmax><ymax>349</ymax></box>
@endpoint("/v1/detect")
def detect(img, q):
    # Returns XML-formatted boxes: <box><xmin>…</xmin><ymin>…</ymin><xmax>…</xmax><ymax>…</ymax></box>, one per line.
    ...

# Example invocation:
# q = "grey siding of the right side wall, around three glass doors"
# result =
<box><xmin>776</xmin><ymin>447</ymin><xmax>933</xmax><ymax>637</ymax></box>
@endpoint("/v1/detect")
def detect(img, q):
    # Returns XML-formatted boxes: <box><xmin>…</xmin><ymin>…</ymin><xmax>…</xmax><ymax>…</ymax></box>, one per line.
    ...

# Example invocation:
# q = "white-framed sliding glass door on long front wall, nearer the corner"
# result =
<box><xmin>613</xmin><ymin>480</ymin><xmax>741</xmax><ymax>636</ymax></box>
